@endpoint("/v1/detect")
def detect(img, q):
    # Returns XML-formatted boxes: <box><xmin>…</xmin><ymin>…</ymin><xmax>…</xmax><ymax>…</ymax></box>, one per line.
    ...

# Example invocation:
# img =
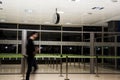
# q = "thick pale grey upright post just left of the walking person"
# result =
<box><xmin>21</xmin><ymin>30</ymin><xmax>27</xmax><ymax>80</ymax></box>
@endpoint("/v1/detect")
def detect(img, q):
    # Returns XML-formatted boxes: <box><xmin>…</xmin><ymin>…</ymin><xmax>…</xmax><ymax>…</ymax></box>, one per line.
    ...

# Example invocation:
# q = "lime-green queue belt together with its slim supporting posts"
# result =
<box><xmin>0</xmin><ymin>53</ymin><xmax>120</xmax><ymax>79</ymax></box>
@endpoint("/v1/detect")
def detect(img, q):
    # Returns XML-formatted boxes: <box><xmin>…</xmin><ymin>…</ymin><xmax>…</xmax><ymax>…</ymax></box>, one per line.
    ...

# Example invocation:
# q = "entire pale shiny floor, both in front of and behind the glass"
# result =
<box><xmin>0</xmin><ymin>63</ymin><xmax>120</xmax><ymax>80</ymax></box>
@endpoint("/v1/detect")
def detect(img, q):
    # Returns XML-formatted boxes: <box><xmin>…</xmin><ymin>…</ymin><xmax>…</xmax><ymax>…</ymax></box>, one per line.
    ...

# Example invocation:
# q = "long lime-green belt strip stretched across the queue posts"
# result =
<box><xmin>0</xmin><ymin>53</ymin><xmax>120</xmax><ymax>59</ymax></box>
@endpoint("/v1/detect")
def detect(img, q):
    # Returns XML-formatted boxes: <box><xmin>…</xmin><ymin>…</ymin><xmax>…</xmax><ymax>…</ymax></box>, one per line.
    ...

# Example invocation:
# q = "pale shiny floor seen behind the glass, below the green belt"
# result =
<box><xmin>0</xmin><ymin>63</ymin><xmax>120</xmax><ymax>74</ymax></box>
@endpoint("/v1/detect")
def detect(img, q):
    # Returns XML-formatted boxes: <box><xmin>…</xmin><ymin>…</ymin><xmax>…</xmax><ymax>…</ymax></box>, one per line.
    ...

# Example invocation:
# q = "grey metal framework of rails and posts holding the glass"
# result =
<box><xmin>0</xmin><ymin>27</ymin><xmax>120</xmax><ymax>74</ymax></box>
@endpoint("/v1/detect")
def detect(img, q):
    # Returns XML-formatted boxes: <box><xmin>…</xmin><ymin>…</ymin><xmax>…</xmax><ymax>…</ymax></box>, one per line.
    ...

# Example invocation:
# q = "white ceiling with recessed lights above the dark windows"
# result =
<box><xmin>0</xmin><ymin>0</ymin><xmax>120</xmax><ymax>26</ymax></box>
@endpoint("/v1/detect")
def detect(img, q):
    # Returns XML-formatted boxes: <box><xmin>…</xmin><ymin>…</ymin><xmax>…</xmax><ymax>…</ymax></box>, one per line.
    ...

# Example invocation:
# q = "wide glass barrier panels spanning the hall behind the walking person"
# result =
<box><xmin>0</xmin><ymin>29</ymin><xmax>120</xmax><ymax>73</ymax></box>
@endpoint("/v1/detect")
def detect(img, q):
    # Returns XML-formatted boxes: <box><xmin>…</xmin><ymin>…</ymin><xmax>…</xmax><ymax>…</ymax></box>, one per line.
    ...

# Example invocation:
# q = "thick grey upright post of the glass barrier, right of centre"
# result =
<box><xmin>90</xmin><ymin>33</ymin><xmax>95</xmax><ymax>74</ymax></box>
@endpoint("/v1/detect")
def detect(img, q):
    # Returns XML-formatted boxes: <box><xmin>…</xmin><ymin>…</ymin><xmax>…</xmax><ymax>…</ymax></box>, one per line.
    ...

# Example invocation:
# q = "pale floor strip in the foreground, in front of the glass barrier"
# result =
<box><xmin>0</xmin><ymin>74</ymin><xmax>120</xmax><ymax>80</ymax></box>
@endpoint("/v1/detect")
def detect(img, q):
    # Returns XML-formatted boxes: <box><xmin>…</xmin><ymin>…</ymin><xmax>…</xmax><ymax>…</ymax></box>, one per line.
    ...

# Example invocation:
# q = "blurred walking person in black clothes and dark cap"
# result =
<box><xmin>26</xmin><ymin>32</ymin><xmax>39</xmax><ymax>80</ymax></box>
